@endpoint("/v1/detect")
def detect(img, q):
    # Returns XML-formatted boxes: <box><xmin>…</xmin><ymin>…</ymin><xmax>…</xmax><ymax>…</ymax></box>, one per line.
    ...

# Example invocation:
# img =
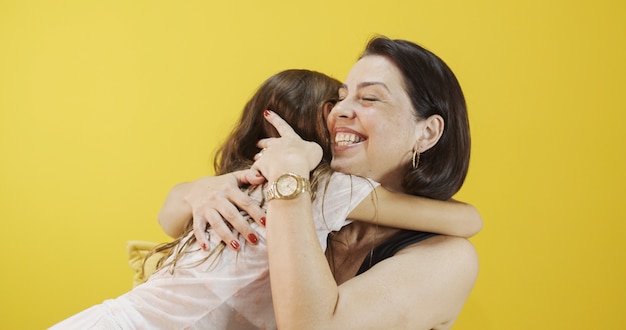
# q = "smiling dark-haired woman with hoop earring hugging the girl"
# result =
<box><xmin>172</xmin><ymin>37</ymin><xmax>478</xmax><ymax>329</ymax></box>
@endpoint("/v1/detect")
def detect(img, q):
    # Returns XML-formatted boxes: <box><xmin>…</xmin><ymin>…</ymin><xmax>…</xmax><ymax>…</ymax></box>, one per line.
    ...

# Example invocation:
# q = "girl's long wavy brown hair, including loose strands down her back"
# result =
<box><xmin>142</xmin><ymin>69</ymin><xmax>341</xmax><ymax>277</ymax></box>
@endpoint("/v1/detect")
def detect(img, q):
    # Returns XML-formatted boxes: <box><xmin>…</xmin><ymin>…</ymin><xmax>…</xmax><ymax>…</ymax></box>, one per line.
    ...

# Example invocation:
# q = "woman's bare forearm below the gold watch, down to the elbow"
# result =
<box><xmin>267</xmin><ymin>194</ymin><xmax>338</xmax><ymax>329</ymax></box>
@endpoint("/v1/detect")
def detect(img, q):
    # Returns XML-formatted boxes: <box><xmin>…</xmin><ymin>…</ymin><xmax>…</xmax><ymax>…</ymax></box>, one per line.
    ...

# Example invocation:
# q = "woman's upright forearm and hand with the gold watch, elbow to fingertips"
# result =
<box><xmin>253</xmin><ymin>111</ymin><xmax>338</xmax><ymax>329</ymax></box>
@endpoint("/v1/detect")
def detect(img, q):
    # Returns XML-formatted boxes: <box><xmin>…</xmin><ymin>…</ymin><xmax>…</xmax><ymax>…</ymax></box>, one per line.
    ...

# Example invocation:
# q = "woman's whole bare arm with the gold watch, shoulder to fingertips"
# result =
<box><xmin>255</xmin><ymin>114</ymin><xmax>478</xmax><ymax>329</ymax></box>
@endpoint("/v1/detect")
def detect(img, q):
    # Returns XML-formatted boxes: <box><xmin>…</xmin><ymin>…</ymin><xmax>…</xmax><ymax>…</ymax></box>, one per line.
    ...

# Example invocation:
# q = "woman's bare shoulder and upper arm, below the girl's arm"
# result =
<box><xmin>341</xmin><ymin>235</ymin><xmax>478</xmax><ymax>329</ymax></box>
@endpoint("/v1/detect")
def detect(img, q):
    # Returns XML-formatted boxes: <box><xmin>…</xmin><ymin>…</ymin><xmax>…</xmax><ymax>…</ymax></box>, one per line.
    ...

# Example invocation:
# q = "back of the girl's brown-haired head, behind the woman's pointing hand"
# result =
<box><xmin>214</xmin><ymin>69</ymin><xmax>341</xmax><ymax>174</ymax></box>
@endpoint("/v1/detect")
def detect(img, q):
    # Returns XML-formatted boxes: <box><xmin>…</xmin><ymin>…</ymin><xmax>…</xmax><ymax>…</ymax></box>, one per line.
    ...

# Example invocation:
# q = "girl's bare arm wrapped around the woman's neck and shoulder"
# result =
<box><xmin>349</xmin><ymin>186</ymin><xmax>483</xmax><ymax>238</ymax></box>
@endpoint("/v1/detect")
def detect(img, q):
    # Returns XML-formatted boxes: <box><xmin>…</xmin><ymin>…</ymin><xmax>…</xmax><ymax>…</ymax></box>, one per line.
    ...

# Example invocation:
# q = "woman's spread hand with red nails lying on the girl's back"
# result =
<box><xmin>184</xmin><ymin>170</ymin><xmax>265</xmax><ymax>249</ymax></box>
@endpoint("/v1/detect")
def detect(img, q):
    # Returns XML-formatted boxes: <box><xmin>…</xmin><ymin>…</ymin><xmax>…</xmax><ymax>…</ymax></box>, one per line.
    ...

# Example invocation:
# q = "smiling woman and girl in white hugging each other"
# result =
<box><xmin>51</xmin><ymin>37</ymin><xmax>482</xmax><ymax>329</ymax></box>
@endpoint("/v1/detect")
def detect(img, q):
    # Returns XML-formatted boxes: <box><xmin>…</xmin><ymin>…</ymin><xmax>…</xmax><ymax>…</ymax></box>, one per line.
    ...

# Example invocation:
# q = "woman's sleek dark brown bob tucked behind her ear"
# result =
<box><xmin>361</xmin><ymin>37</ymin><xmax>471</xmax><ymax>200</ymax></box>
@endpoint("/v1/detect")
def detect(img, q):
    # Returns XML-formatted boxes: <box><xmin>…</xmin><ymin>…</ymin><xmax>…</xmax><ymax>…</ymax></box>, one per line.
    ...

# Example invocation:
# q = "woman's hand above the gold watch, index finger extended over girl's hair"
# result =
<box><xmin>252</xmin><ymin>110</ymin><xmax>323</xmax><ymax>182</ymax></box>
